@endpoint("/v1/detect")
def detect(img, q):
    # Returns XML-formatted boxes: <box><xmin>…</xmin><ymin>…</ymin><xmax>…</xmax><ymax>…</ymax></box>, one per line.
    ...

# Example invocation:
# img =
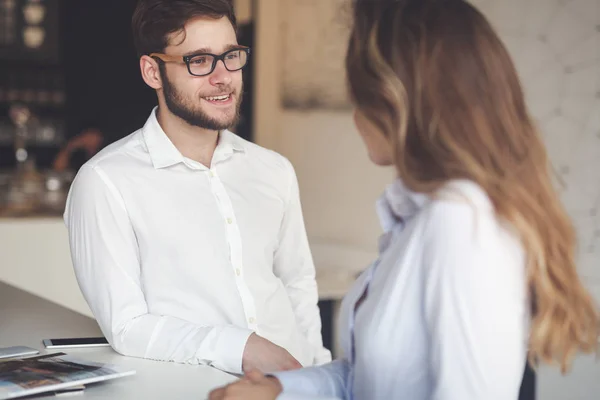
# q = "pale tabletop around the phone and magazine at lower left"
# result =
<box><xmin>0</xmin><ymin>282</ymin><xmax>236</xmax><ymax>400</ymax></box>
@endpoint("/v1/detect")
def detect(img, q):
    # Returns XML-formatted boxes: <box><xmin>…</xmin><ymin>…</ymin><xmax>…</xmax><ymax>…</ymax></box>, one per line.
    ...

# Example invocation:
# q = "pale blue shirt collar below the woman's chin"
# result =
<box><xmin>376</xmin><ymin>179</ymin><xmax>429</xmax><ymax>233</ymax></box>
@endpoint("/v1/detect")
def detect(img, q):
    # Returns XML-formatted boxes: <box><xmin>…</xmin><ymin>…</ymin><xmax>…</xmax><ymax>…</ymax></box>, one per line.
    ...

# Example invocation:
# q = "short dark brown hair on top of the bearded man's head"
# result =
<box><xmin>131</xmin><ymin>0</ymin><xmax>236</xmax><ymax>57</ymax></box>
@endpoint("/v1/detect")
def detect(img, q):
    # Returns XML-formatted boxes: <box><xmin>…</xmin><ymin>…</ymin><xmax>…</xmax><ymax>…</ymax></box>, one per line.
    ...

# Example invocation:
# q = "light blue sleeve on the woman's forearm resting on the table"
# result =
<box><xmin>272</xmin><ymin>360</ymin><xmax>350</xmax><ymax>400</ymax></box>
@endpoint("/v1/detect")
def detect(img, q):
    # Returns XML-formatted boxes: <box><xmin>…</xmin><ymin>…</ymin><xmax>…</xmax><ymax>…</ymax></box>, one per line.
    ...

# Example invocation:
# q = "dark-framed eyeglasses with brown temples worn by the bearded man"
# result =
<box><xmin>150</xmin><ymin>46</ymin><xmax>250</xmax><ymax>76</ymax></box>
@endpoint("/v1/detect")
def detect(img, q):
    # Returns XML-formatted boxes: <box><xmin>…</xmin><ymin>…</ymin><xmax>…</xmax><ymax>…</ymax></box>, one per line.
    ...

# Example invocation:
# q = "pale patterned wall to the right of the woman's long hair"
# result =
<box><xmin>473</xmin><ymin>0</ymin><xmax>600</xmax><ymax>282</ymax></box>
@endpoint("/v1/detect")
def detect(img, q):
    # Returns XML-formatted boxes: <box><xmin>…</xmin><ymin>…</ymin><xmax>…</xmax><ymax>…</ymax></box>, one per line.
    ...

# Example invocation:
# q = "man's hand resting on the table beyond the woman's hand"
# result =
<box><xmin>242</xmin><ymin>333</ymin><xmax>302</xmax><ymax>373</ymax></box>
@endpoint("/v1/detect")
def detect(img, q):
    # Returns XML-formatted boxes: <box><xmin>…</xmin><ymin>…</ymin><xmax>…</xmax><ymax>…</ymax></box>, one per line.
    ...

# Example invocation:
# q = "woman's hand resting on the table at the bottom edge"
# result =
<box><xmin>208</xmin><ymin>370</ymin><xmax>283</xmax><ymax>400</ymax></box>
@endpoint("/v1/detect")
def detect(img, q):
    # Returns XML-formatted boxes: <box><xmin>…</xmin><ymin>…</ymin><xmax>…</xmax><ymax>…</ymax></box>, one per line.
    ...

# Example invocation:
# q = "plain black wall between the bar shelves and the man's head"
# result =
<box><xmin>62</xmin><ymin>0</ymin><xmax>156</xmax><ymax>143</ymax></box>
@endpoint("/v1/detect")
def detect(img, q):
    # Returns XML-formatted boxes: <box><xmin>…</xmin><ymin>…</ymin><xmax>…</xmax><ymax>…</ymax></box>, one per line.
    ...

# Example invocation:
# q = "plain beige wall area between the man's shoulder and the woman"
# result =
<box><xmin>278</xmin><ymin>112</ymin><xmax>393</xmax><ymax>251</ymax></box>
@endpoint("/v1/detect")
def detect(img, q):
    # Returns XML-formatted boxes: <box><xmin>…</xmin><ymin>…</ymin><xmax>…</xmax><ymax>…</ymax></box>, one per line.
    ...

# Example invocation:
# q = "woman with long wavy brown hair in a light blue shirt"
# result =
<box><xmin>211</xmin><ymin>0</ymin><xmax>599</xmax><ymax>400</ymax></box>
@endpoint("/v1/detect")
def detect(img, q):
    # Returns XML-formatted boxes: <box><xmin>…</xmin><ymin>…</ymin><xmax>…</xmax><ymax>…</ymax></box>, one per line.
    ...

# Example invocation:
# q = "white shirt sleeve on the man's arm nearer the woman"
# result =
<box><xmin>274</xmin><ymin>159</ymin><xmax>331</xmax><ymax>364</ymax></box>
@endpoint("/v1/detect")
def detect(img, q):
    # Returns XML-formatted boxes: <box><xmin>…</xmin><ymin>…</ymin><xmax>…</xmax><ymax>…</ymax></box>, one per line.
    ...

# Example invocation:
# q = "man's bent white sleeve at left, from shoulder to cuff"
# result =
<box><xmin>65</xmin><ymin>165</ymin><xmax>252</xmax><ymax>373</ymax></box>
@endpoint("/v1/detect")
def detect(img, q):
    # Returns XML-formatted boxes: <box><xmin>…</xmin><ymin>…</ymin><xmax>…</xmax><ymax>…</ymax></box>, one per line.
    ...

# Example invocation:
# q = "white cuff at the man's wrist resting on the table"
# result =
<box><xmin>206</xmin><ymin>326</ymin><xmax>254</xmax><ymax>374</ymax></box>
